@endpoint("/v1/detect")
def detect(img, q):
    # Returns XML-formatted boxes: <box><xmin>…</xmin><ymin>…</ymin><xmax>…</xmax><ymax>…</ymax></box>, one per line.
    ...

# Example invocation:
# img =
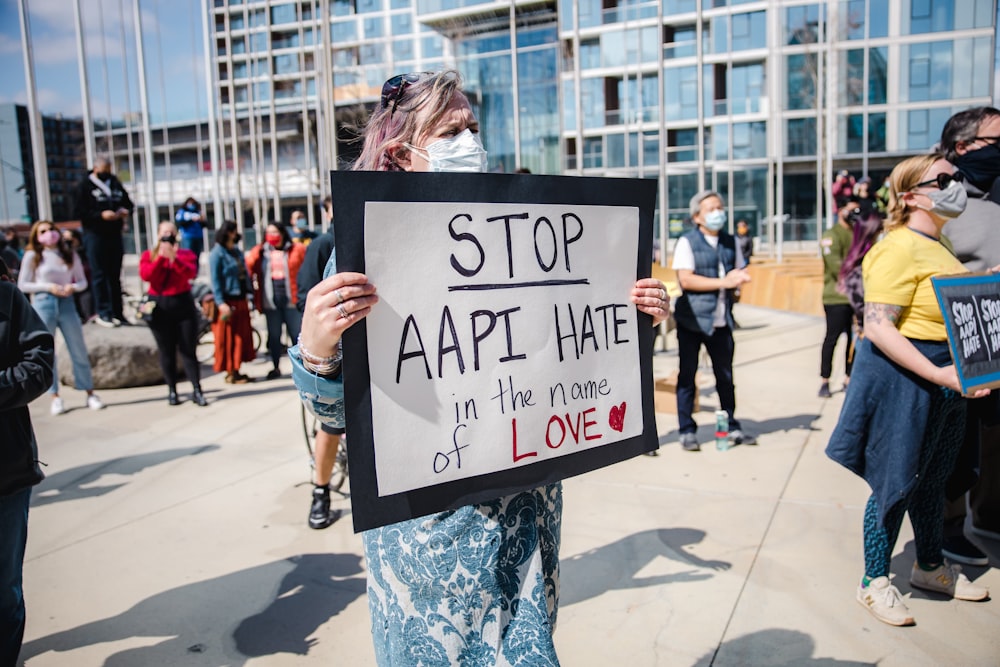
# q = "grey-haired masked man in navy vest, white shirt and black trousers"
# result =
<box><xmin>673</xmin><ymin>190</ymin><xmax>756</xmax><ymax>452</ymax></box>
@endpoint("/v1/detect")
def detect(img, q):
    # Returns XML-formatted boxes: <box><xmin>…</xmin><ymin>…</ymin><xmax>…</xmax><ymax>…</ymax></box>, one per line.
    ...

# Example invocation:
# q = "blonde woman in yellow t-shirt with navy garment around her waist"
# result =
<box><xmin>826</xmin><ymin>155</ymin><xmax>989</xmax><ymax>625</ymax></box>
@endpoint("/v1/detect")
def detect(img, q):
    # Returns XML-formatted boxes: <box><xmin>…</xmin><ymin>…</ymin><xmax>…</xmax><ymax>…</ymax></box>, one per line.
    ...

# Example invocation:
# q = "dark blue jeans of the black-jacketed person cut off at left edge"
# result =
<box><xmin>0</xmin><ymin>487</ymin><xmax>31</xmax><ymax>665</ymax></box>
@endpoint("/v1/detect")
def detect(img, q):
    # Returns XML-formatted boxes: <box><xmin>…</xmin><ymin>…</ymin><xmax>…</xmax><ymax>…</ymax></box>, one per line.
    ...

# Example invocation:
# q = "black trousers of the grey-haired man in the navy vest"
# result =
<box><xmin>677</xmin><ymin>327</ymin><xmax>740</xmax><ymax>434</ymax></box>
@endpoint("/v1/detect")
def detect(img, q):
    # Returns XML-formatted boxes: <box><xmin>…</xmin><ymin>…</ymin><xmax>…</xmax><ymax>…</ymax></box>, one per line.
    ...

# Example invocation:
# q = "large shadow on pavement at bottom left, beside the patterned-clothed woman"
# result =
<box><xmin>20</xmin><ymin>553</ymin><xmax>365</xmax><ymax>667</ymax></box>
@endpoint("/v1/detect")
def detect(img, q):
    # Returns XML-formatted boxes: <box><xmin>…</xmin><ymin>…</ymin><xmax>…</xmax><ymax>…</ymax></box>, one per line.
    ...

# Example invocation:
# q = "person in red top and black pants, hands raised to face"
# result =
<box><xmin>139</xmin><ymin>222</ymin><xmax>208</xmax><ymax>407</ymax></box>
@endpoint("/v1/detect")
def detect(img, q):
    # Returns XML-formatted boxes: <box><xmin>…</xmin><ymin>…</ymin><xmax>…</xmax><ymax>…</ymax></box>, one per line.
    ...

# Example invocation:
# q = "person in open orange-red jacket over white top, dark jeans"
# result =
<box><xmin>247</xmin><ymin>222</ymin><xmax>306</xmax><ymax>380</ymax></box>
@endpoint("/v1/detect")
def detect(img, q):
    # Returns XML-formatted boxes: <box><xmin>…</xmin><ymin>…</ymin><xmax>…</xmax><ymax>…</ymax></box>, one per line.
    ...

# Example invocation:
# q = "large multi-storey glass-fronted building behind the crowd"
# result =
<box><xmin>109</xmin><ymin>0</ymin><xmax>997</xmax><ymax>248</ymax></box>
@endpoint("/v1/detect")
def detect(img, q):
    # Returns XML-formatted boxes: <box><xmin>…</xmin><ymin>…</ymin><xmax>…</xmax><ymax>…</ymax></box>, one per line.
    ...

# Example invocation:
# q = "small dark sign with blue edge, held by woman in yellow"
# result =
<box><xmin>931</xmin><ymin>273</ymin><xmax>1000</xmax><ymax>394</ymax></box>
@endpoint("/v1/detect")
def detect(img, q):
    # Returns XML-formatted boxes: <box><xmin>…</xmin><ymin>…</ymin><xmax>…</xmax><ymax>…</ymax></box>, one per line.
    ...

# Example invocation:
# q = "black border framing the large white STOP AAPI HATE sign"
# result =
<box><xmin>330</xmin><ymin>171</ymin><xmax>659</xmax><ymax>532</ymax></box>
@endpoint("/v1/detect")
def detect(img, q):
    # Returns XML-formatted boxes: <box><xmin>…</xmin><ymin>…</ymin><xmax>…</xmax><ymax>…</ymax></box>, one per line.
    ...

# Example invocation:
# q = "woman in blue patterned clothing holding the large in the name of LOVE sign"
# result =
<box><xmin>290</xmin><ymin>71</ymin><xmax>669</xmax><ymax>666</ymax></box>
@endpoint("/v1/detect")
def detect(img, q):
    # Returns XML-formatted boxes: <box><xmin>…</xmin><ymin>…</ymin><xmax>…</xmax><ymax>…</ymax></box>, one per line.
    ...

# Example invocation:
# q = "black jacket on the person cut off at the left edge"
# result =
<box><xmin>0</xmin><ymin>280</ymin><xmax>55</xmax><ymax>496</ymax></box>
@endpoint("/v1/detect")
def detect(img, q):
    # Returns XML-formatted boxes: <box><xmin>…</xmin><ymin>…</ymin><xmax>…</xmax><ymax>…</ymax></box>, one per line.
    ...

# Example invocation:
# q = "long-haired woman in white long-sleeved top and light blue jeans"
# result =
<box><xmin>17</xmin><ymin>220</ymin><xmax>104</xmax><ymax>415</ymax></box>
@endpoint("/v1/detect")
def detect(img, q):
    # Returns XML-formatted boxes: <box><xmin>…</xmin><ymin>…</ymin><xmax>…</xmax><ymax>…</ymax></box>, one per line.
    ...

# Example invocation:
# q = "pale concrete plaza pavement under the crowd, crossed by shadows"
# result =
<box><xmin>15</xmin><ymin>305</ymin><xmax>1000</xmax><ymax>667</ymax></box>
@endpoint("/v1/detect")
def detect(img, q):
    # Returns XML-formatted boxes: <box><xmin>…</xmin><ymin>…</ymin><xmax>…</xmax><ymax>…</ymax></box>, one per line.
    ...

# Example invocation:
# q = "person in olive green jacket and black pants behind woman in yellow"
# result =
<box><xmin>819</xmin><ymin>195</ymin><xmax>861</xmax><ymax>398</ymax></box>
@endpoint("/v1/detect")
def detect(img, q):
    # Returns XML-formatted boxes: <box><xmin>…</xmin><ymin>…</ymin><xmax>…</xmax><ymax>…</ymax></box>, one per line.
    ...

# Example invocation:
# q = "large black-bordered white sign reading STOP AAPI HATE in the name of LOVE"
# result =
<box><xmin>331</xmin><ymin>172</ymin><xmax>657</xmax><ymax>530</ymax></box>
